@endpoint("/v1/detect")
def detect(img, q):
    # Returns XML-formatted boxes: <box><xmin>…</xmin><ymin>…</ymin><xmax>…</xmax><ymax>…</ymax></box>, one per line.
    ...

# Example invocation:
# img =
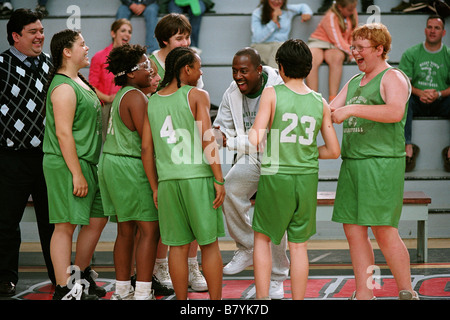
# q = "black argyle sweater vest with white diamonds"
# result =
<box><xmin>0</xmin><ymin>49</ymin><xmax>52</xmax><ymax>150</ymax></box>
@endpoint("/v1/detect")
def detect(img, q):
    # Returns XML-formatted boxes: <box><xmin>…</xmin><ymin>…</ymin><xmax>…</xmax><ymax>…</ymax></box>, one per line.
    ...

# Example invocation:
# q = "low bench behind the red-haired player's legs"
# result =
<box><xmin>316</xmin><ymin>191</ymin><xmax>431</xmax><ymax>262</ymax></box>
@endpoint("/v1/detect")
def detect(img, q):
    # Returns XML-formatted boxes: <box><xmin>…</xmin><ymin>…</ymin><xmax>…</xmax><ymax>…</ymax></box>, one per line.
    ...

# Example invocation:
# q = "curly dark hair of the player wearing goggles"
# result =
<box><xmin>106</xmin><ymin>43</ymin><xmax>147</xmax><ymax>87</ymax></box>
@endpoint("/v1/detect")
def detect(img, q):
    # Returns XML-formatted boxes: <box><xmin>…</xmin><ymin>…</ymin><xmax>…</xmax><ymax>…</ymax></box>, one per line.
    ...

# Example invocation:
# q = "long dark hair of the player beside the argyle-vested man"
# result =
<box><xmin>44</xmin><ymin>29</ymin><xmax>96</xmax><ymax>100</ymax></box>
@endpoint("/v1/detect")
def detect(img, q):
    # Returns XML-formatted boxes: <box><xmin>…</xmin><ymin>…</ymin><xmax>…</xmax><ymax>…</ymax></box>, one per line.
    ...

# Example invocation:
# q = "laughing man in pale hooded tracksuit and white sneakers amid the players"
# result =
<box><xmin>214</xmin><ymin>48</ymin><xmax>289</xmax><ymax>299</ymax></box>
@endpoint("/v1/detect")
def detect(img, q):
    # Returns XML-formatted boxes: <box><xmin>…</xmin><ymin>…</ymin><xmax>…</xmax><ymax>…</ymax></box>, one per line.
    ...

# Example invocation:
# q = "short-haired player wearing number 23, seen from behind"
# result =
<box><xmin>249</xmin><ymin>40</ymin><xmax>340</xmax><ymax>300</ymax></box>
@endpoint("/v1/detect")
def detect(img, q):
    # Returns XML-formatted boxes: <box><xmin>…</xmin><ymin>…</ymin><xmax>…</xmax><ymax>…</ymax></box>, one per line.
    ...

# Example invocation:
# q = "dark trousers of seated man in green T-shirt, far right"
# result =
<box><xmin>405</xmin><ymin>95</ymin><xmax>450</xmax><ymax>144</ymax></box>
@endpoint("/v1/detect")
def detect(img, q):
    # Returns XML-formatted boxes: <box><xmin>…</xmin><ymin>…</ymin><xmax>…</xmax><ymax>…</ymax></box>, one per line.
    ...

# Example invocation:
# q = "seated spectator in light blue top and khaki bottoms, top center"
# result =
<box><xmin>251</xmin><ymin>0</ymin><xmax>313</xmax><ymax>68</ymax></box>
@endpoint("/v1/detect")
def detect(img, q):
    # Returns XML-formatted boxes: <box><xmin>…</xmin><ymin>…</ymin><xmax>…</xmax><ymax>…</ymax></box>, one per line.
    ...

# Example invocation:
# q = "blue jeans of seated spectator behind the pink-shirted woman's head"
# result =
<box><xmin>116</xmin><ymin>1</ymin><xmax>159</xmax><ymax>53</ymax></box>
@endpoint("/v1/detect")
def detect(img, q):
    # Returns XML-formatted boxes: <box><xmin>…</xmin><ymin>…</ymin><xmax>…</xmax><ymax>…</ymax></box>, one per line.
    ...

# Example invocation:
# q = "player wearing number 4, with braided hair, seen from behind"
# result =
<box><xmin>142</xmin><ymin>47</ymin><xmax>225</xmax><ymax>300</ymax></box>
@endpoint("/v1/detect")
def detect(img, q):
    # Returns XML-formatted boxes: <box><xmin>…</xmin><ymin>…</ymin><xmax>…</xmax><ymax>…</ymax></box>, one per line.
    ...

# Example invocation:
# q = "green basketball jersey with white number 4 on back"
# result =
<box><xmin>148</xmin><ymin>85</ymin><xmax>213</xmax><ymax>181</ymax></box>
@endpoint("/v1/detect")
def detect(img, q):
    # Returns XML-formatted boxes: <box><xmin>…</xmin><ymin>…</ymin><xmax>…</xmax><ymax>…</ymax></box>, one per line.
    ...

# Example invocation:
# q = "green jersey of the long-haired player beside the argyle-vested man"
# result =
<box><xmin>43</xmin><ymin>74</ymin><xmax>102</xmax><ymax>164</ymax></box>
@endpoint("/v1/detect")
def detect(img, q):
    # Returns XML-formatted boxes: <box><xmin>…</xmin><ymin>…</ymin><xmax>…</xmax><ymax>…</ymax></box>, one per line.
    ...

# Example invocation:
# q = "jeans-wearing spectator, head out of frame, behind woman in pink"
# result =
<box><xmin>116</xmin><ymin>0</ymin><xmax>159</xmax><ymax>53</ymax></box>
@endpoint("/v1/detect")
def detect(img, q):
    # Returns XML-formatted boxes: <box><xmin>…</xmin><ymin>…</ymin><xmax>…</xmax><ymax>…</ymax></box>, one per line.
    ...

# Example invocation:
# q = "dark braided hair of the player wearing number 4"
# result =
<box><xmin>161</xmin><ymin>47</ymin><xmax>197</xmax><ymax>88</ymax></box>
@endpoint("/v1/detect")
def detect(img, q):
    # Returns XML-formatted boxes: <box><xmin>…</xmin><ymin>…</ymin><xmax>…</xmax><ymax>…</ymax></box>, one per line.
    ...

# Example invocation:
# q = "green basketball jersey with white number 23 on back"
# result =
<box><xmin>261</xmin><ymin>84</ymin><xmax>323</xmax><ymax>174</ymax></box>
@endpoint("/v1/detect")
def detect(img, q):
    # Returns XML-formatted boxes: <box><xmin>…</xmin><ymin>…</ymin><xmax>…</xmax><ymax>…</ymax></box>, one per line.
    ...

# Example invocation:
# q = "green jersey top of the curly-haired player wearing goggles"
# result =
<box><xmin>103</xmin><ymin>86</ymin><xmax>141</xmax><ymax>158</ymax></box>
